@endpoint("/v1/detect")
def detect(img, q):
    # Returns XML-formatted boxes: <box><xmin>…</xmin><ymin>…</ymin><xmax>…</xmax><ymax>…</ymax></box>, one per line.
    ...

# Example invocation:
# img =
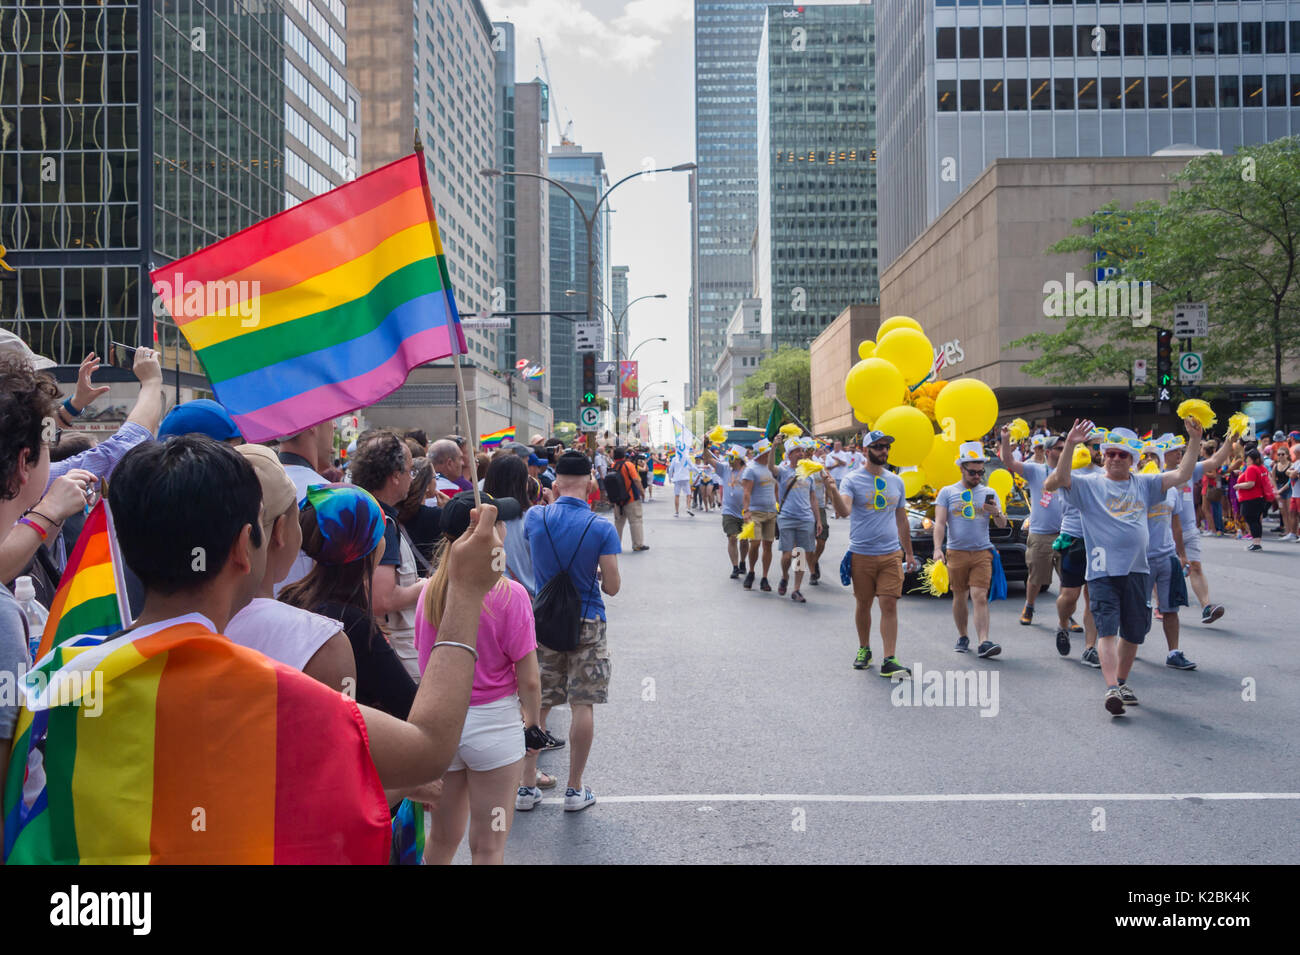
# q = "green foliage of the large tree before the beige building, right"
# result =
<box><xmin>1009</xmin><ymin>136</ymin><xmax>1300</xmax><ymax>420</ymax></box>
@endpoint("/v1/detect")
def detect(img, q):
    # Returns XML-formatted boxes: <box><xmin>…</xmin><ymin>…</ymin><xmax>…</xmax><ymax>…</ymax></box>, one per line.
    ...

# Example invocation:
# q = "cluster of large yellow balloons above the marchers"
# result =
<box><xmin>844</xmin><ymin>314</ymin><xmax>1010</xmax><ymax>498</ymax></box>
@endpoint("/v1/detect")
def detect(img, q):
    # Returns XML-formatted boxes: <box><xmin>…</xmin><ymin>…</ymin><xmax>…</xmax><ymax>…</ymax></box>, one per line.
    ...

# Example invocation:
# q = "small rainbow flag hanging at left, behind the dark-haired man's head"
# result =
<box><xmin>36</xmin><ymin>498</ymin><xmax>131</xmax><ymax>660</ymax></box>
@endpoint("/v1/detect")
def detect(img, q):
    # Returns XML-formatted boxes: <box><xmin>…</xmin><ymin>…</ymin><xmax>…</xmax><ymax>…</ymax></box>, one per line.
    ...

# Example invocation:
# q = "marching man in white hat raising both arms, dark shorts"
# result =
<box><xmin>1044</xmin><ymin>417</ymin><xmax>1201</xmax><ymax>716</ymax></box>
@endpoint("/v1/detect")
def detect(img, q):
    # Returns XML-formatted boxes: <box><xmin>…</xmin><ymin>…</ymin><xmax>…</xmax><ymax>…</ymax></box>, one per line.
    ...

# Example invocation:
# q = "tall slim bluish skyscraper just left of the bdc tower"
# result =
<box><xmin>688</xmin><ymin>0</ymin><xmax>790</xmax><ymax>404</ymax></box>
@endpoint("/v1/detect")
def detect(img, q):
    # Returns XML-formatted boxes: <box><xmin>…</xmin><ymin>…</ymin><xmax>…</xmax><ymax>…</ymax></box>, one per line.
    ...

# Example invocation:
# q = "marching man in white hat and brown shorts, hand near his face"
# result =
<box><xmin>933</xmin><ymin>440</ymin><xmax>1006</xmax><ymax>657</ymax></box>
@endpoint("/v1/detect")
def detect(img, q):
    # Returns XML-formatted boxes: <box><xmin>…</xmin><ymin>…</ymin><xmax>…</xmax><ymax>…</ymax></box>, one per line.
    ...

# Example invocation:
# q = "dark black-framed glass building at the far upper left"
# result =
<box><xmin>0</xmin><ymin>0</ymin><xmax>285</xmax><ymax>385</ymax></box>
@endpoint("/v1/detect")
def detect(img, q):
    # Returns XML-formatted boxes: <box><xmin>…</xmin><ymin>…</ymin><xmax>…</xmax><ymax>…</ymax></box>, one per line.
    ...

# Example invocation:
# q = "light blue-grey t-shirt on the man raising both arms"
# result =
<box><xmin>1063</xmin><ymin>470</ymin><xmax>1165</xmax><ymax>581</ymax></box>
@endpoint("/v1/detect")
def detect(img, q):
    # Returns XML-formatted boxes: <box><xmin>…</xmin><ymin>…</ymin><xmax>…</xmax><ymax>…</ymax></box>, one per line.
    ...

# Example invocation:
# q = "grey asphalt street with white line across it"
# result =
<box><xmin>459</xmin><ymin>500</ymin><xmax>1300</xmax><ymax>864</ymax></box>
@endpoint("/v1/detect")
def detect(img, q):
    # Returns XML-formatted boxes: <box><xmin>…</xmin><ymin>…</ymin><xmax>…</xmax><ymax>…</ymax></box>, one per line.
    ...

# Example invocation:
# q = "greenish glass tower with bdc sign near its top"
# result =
<box><xmin>757</xmin><ymin>4</ymin><xmax>880</xmax><ymax>348</ymax></box>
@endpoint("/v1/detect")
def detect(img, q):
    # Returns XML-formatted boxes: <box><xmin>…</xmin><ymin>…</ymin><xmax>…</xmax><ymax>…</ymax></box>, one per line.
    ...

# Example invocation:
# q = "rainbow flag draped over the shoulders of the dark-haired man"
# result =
<box><xmin>4</xmin><ymin>618</ymin><xmax>393</xmax><ymax>865</ymax></box>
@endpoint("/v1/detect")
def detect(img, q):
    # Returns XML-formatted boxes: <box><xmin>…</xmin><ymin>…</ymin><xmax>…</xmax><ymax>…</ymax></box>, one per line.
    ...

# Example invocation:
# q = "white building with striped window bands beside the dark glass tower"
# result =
<box><xmin>283</xmin><ymin>0</ymin><xmax>361</xmax><ymax>209</ymax></box>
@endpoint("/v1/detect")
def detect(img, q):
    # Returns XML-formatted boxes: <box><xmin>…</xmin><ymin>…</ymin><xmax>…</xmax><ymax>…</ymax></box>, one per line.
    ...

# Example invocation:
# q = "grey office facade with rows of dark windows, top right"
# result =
<box><xmin>879</xmin><ymin>0</ymin><xmax>1300</xmax><ymax>266</ymax></box>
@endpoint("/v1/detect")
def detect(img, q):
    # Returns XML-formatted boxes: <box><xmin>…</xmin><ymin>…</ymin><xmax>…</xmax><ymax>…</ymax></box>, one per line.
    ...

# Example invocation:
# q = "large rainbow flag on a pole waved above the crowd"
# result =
<box><xmin>151</xmin><ymin>152</ymin><xmax>467</xmax><ymax>442</ymax></box>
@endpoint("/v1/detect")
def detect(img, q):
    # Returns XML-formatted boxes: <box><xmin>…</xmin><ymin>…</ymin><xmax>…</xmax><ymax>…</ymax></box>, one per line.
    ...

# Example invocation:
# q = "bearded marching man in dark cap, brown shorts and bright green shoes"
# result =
<box><xmin>823</xmin><ymin>431</ymin><xmax>917</xmax><ymax>678</ymax></box>
